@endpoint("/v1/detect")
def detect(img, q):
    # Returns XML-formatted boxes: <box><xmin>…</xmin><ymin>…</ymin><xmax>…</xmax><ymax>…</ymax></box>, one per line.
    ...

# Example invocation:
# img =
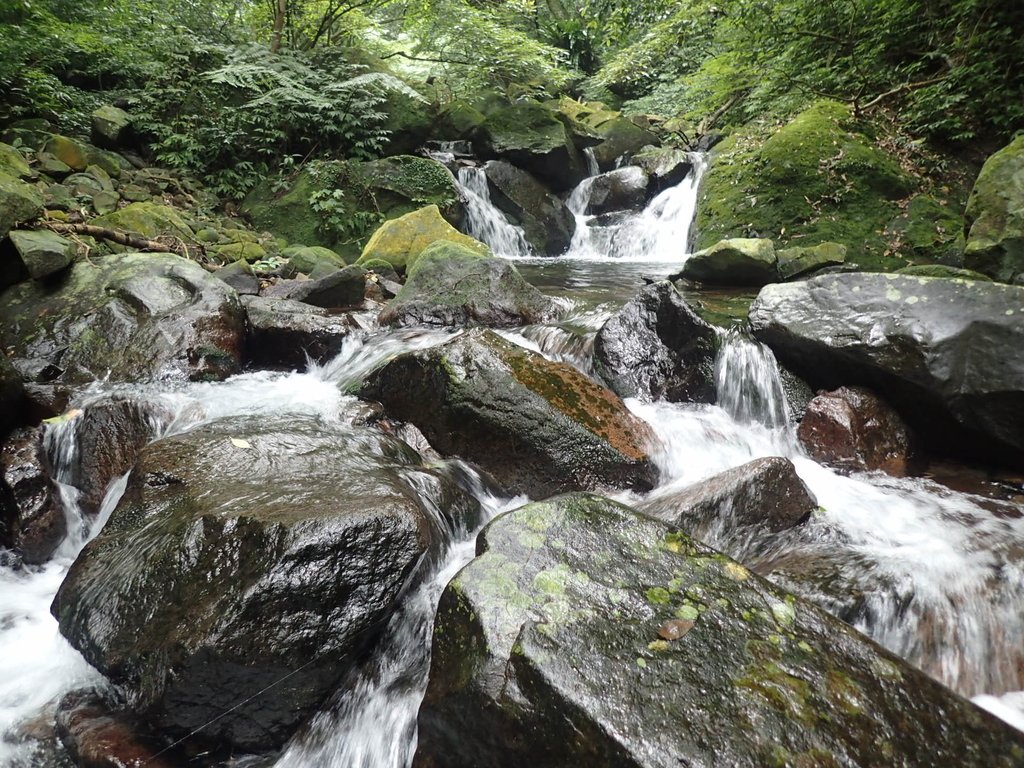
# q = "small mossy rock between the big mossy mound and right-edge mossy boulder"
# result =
<box><xmin>887</xmin><ymin>195</ymin><xmax>965</xmax><ymax>266</ymax></box>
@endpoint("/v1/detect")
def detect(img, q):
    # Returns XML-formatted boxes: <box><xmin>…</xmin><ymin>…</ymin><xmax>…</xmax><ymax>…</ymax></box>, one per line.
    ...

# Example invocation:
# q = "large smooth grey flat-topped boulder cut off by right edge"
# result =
<box><xmin>750</xmin><ymin>273</ymin><xmax>1024</xmax><ymax>464</ymax></box>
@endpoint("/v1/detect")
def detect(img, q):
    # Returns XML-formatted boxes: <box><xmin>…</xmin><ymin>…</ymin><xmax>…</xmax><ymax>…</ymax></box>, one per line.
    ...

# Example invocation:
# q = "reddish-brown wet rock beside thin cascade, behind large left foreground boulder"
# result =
<box><xmin>68</xmin><ymin>395</ymin><xmax>174</xmax><ymax>516</ymax></box>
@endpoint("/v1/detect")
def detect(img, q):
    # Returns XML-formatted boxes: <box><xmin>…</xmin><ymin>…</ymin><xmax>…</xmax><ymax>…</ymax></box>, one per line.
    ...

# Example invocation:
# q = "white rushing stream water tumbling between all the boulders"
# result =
<box><xmin>0</xmin><ymin>156</ymin><xmax>1024</xmax><ymax>768</ymax></box>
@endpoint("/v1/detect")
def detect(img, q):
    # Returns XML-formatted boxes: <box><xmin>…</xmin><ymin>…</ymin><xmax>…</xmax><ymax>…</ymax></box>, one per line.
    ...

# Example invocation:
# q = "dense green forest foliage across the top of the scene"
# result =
<box><xmin>0</xmin><ymin>0</ymin><xmax>1024</xmax><ymax>197</ymax></box>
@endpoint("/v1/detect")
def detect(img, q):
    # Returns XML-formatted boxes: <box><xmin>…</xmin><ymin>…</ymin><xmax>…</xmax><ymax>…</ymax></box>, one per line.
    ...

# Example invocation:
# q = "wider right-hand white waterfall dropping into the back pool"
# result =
<box><xmin>565</xmin><ymin>153</ymin><xmax>708</xmax><ymax>264</ymax></box>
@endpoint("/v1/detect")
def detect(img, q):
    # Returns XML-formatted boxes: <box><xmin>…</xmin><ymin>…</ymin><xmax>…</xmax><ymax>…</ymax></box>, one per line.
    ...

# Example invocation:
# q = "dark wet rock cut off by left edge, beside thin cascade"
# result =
<box><xmin>0</xmin><ymin>427</ymin><xmax>68</xmax><ymax>563</ymax></box>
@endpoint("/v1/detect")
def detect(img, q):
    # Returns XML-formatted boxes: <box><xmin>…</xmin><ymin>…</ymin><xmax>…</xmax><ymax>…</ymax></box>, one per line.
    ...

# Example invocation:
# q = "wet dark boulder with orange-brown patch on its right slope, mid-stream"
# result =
<box><xmin>361</xmin><ymin>330</ymin><xmax>656</xmax><ymax>496</ymax></box>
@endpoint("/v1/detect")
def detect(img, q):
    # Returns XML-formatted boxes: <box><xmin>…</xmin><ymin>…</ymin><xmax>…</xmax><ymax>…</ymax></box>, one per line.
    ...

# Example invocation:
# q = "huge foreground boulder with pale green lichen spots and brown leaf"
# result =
<box><xmin>413</xmin><ymin>495</ymin><xmax>1024</xmax><ymax>768</ymax></box>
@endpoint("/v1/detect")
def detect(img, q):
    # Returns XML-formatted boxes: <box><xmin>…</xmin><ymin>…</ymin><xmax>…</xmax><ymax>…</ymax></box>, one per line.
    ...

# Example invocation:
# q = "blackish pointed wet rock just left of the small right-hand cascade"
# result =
<box><xmin>594</xmin><ymin>281</ymin><xmax>719</xmax><ymax>402</ymax></box>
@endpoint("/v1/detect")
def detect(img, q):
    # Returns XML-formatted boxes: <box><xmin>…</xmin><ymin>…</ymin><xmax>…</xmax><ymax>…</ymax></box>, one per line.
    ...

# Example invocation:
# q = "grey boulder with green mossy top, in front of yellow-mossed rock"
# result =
<box><xmin>380</xmin><ymin>241</ymin><xmax>556</xmax><ymax>328</ymax></box>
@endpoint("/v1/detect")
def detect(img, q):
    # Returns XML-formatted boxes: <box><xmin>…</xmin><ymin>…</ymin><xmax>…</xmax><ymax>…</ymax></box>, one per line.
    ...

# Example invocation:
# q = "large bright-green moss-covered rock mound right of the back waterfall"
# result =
<box><xmin>696</xmin><ymin>101</ymin><xmax>913</xmax><ymax>270</ymax></box>
